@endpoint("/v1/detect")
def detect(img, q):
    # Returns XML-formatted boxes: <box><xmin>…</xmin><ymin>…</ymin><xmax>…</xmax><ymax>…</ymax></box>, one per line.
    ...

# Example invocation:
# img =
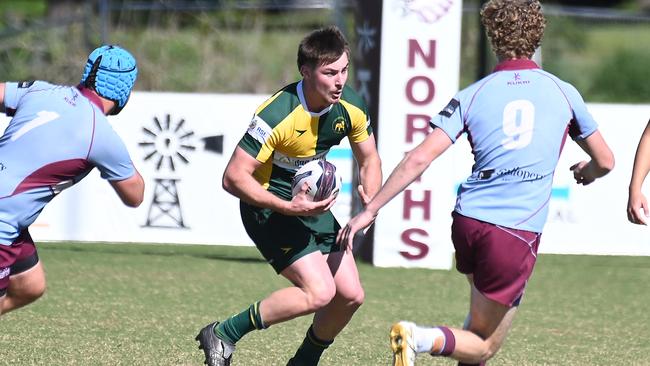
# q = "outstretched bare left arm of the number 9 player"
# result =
<box><xmin>337</xmin><ymin>128</ymin><xmax>452</xmax><ymax>250</ymax></box>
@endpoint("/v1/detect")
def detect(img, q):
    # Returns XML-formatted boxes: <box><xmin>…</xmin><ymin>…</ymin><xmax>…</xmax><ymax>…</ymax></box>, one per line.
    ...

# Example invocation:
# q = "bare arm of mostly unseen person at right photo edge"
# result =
<box><xmin>627</xmin><ymin>121</ymin><xmax>650</xmax><ymax>225</ymax></box>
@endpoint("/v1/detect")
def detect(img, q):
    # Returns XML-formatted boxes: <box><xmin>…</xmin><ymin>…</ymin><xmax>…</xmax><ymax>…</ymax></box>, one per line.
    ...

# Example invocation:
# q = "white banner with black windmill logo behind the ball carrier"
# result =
<box><xmin>0</xmin><ymin>92</ymin><xmax>352</xmax><ymax>245</ymax></box>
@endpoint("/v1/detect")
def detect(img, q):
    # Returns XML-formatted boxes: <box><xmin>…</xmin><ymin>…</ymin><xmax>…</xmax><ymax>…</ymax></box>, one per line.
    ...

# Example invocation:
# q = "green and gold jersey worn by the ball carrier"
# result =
<box><xmin>239</xmin><ymin>81</ymin><xmax>372</xmax><ymax>199</ymax></box>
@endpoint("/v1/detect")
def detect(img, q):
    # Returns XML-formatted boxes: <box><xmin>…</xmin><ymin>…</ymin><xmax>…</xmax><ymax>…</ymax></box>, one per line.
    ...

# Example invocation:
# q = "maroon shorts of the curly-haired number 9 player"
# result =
<box><xmin>451</xmin><ymin>212</ymin><xmax>542</xmax><ymax>306</ymax></box>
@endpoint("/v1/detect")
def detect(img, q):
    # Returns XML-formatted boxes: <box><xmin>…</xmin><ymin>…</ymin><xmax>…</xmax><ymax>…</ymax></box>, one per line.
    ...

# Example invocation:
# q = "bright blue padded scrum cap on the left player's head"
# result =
<box><xmin>81</xmin><ymin>45</ymin><xmax>138</xmax><ymax>115</ymax></box>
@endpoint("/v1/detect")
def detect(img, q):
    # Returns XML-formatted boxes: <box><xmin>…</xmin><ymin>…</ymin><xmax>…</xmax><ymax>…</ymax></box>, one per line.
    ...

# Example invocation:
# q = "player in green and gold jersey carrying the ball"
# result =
<box><xmin>196</xmin><ymin>26</ymin><xmax>382</xmax><ymax>366</ymax></box>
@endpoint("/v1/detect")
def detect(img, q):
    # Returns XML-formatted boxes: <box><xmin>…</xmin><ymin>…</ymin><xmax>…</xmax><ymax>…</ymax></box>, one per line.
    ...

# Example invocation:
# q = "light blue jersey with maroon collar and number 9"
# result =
<box><xmin>431</xmin><ymin>60</ymin><xmax>597</xmax><ymax>233</ymax></box>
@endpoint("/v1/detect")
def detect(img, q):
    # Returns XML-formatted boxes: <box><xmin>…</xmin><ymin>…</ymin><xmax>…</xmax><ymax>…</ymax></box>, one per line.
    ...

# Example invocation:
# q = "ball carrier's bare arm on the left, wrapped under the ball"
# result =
<box><xmin>222</xmin><ymin>147</ymin><xmax>335</xmax><ymax>216</ymax></box>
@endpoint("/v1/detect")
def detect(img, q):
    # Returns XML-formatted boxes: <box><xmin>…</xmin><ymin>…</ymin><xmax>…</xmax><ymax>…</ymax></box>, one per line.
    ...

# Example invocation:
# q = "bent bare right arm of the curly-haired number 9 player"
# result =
<box><xmin>570</xmin><ymin>131</ymin><xmax>614</xmax><ymax>185</ymax></box>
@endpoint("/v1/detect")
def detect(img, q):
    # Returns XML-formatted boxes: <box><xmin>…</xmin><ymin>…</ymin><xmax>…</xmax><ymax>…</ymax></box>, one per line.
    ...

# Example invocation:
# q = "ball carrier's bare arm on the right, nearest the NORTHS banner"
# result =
<box><xmin>350</xmin><ymin>135</ymin><xmax>382</xmax><ymax>205</ymax></box>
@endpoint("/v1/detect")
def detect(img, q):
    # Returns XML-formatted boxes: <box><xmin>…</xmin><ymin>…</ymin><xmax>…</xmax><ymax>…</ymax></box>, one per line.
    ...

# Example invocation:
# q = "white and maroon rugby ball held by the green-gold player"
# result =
<box><xmin>291</xmin><ymin>160</ymin><xmax>342</xmax><ymax>201</ymax></box>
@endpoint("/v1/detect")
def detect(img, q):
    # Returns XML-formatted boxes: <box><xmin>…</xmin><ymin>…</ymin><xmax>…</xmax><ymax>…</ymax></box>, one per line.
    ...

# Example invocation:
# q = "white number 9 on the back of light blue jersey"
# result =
<box><xmin>501</xmin><ymin>99</ymin><xmax>535</xmax><ymax>150</ymax></box>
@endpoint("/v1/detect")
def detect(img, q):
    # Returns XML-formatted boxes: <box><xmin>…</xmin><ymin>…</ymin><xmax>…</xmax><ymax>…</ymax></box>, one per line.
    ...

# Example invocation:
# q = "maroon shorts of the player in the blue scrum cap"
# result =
<box><xmin>0</xmin><ymin>229</ymin><xmax>38</xmax><ymax>296</ymax></box>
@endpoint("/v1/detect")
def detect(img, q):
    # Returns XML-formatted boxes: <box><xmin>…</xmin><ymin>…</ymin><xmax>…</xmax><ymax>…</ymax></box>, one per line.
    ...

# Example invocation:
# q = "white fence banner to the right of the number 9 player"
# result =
<box><xmin>539</xmin><ymin>104</ymin><xmax>650</xmax><ymax>255</ymax></box>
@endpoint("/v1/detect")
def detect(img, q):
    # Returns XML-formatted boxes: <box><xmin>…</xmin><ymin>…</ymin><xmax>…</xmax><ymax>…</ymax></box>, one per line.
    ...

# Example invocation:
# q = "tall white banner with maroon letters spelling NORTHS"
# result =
<box><xmin>373</xmin><ymin>0</ymin><xmax>462</xmax><ymax>268</ymax></box>
